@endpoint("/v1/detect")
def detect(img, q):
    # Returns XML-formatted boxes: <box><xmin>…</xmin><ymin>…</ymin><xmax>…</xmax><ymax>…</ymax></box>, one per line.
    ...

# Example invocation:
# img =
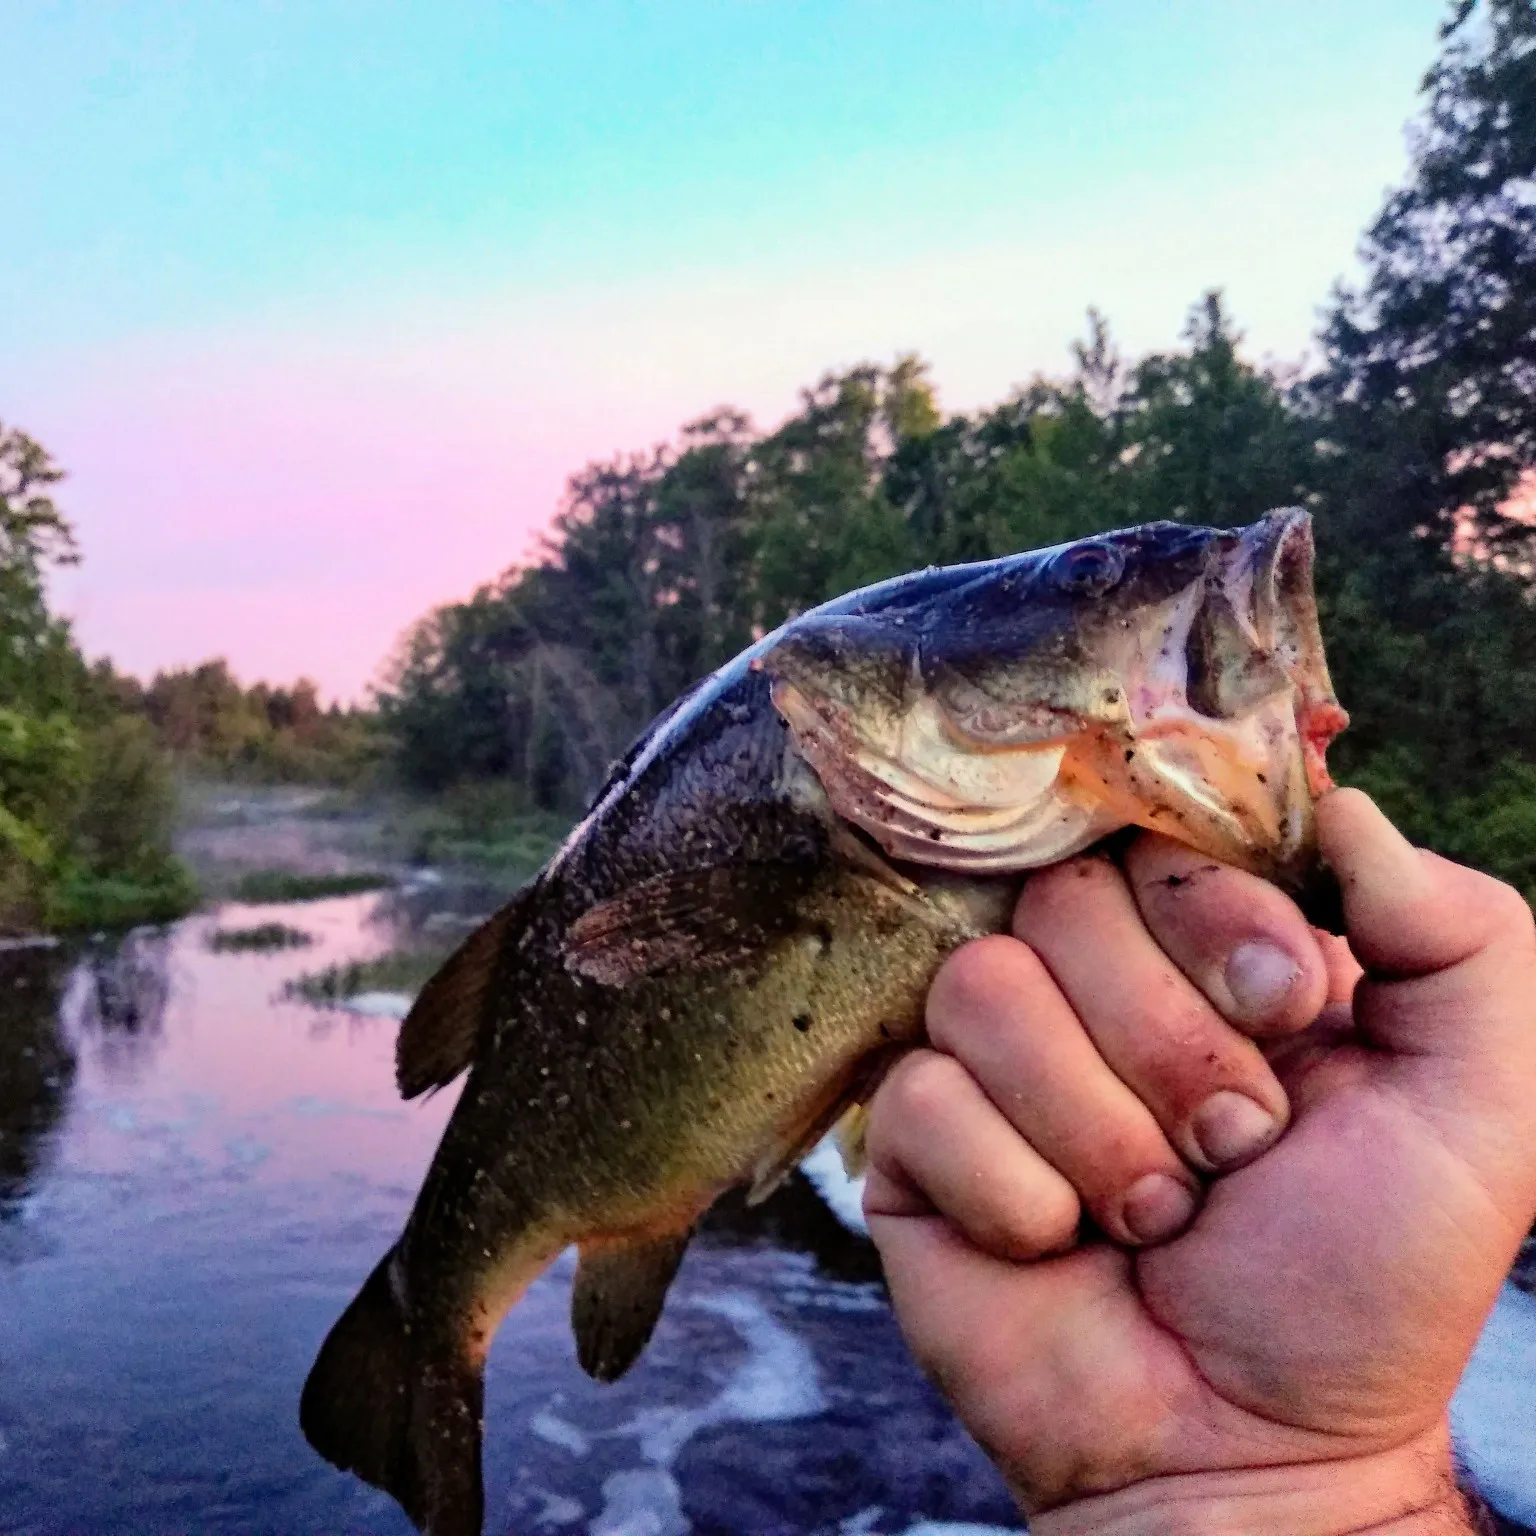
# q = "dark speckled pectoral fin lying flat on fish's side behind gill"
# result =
<box><xmin>565</xmin><ymin>862</ymin><xmax>809</xmax><ymax>986</ymax></box>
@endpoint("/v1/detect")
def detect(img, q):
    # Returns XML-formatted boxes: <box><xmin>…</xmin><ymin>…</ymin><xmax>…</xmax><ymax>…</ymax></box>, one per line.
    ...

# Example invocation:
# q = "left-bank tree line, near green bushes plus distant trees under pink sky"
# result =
<box><xmin>0</xmin><ymin>422</ymin><xmax>379</xmax><ymax>937</ymax></box>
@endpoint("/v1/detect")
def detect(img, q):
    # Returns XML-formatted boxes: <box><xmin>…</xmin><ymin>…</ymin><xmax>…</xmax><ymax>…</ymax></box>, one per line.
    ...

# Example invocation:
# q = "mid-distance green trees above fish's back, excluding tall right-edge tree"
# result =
<box><xmin>379</xmin><ymin>295</ymin><xmax>1313</xmax><ymax>816</ymax></box>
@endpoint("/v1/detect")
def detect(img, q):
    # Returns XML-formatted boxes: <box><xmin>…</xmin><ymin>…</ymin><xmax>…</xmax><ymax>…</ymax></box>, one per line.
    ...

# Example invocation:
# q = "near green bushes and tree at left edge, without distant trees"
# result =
<box><xmin>0</xmin><ymin>425</ymin><xmax>194</xmax><ymax>932</ymax></box>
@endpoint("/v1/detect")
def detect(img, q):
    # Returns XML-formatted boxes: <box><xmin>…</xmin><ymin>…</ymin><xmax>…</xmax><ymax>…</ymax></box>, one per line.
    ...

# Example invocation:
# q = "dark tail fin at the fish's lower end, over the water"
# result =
<box><xmin>298</xmin><ymin>1249</ymin><xmax>484</xmax><ymax>1536</ymax></box>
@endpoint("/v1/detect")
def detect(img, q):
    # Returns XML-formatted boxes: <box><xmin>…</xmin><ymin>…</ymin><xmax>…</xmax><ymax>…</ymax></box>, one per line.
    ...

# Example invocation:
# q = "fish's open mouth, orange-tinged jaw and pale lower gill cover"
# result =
<box><xmin>770</xmin><ymin>508</ymin><xmax>1347</xmax><ymax>886</ymax></box>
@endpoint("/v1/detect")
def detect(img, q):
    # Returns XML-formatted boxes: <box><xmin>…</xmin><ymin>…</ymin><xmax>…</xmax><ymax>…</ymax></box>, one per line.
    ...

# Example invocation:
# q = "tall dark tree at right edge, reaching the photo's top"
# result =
<box><xmin>1295</xmin><ymin>0</ymin><xmax>1536</xmax><ymax>866</ymax></box>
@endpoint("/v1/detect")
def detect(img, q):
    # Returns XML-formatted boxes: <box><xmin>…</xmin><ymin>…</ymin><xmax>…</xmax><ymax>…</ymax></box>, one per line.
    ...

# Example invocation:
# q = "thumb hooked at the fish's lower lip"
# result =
<box><xmin>1318</xmin><ymin>790</ymin><xmax>1536</xmax><ymax>1057</ymax></box>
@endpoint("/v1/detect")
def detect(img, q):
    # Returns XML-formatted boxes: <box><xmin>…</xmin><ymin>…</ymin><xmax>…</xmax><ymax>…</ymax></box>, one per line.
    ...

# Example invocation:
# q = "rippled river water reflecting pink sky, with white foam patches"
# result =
<box><xmin>0</xmin><ymin>892</ymin><xmax>1536</xmax><ymax>1536</ymax></box>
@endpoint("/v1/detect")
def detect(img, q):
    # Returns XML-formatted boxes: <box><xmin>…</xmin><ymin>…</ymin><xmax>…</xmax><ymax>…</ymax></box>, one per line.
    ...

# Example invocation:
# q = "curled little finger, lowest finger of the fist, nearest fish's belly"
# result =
<box><xmin>865</xmin><ymin>1051</ymin><xmax>1081</xmax><ymax>1261</ymax></box>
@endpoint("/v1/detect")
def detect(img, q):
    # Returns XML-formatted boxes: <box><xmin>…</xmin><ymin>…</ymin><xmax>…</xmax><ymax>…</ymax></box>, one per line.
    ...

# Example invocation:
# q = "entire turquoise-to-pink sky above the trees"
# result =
<box><xmin>0</xmin><ymin>0</ymin><xmax>1445</xmax><ymax>700</ymax></box>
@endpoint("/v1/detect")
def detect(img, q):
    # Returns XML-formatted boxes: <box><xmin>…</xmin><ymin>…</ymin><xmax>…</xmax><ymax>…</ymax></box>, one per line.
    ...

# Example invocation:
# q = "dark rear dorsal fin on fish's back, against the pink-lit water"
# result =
<box><xmin>395</xmin><ymin>888</ymin><xmax>531</xmax><ymax>1098</ymax></box>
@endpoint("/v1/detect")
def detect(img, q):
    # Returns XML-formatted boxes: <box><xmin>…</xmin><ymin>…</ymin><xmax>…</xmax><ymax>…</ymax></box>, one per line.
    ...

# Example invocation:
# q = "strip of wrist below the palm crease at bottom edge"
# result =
<box><xmin>1029</xmin><ymin>1427</ymin><xmax>1479</xmax><ymax>1536</ymax></box>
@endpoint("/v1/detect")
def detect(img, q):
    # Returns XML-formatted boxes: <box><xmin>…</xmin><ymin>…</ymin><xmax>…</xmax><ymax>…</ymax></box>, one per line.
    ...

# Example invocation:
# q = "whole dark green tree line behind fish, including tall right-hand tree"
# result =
<box><xmin>379</xmin><ymin>0</ymin><xmax>1536</xmax><ymax>892</ymax></box>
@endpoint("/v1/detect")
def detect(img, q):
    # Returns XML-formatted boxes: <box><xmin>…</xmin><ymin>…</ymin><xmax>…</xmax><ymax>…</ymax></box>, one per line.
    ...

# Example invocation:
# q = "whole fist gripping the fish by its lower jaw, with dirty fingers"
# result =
<box><xmin>865</xmin><ymin>790</ymin><xmax>1536</xmax><ymax>1536</ymax></box>
